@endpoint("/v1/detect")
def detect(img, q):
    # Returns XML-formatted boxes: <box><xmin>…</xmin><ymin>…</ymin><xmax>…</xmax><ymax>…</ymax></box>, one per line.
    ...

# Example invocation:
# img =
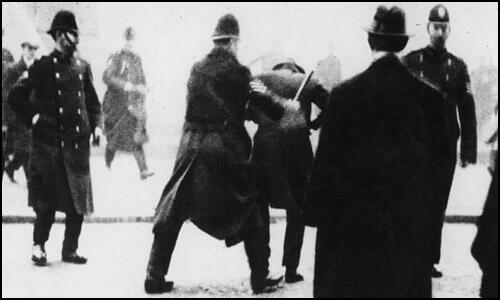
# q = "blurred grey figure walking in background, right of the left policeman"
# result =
<box><xmin>103</xmin><ymin>27</ymin><xmax>154</xmax><ymax>180</ymax></box>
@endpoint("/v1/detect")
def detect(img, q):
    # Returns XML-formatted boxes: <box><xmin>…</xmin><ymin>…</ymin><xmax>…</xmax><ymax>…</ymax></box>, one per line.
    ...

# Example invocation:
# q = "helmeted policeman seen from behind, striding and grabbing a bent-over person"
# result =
<box><xmin>145</xmin><ymin>14</ymin><xmax>283</xmax><ymax>294</ymax></box>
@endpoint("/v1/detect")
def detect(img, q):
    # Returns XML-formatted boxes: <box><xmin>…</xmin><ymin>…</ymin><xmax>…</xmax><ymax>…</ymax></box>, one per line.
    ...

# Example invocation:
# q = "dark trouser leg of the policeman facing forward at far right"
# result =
<box><xmin>431</xmin><ymin>153</ymin><xmax>457</xmax><ymax>264</ymax></box>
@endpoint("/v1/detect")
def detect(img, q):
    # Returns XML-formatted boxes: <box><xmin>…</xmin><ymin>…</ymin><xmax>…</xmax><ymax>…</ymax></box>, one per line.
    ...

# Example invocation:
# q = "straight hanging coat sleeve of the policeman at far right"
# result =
<box><xmin>457</xmin><ymin>64</ymin><xmax>477</xmax><ymax>163</ymax></box>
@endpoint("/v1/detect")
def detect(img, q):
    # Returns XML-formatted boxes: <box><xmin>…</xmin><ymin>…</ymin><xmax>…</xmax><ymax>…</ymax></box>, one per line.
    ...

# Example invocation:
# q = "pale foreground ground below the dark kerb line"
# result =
<box><xmin>2</xmin><ymin>221</ymin><xmax>481</xmax><ymax>298</ymax></box>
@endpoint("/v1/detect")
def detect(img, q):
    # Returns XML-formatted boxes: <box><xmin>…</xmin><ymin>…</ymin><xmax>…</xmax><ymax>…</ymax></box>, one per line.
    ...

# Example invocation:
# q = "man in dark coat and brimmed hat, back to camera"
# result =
<box><xmin>307</xmin><ymin>6</ymin><xmax>445</xmax><ymax>298</ymax></box>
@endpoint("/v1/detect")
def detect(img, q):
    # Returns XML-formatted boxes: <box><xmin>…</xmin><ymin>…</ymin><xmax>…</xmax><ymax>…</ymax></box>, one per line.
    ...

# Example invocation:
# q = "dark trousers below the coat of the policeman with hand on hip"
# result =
<box><xmin>33</xmin><ymin>210</ymin><xmax>83</xmax><ymax>253</ymax></box>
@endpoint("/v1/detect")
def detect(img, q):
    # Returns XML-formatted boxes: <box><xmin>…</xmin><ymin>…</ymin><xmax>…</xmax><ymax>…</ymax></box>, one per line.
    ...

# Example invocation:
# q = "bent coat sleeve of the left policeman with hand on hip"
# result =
<box><xmin>8</xmin><ymin>61</ymin><xmax>43</xmax><ymax>128</ymax></box>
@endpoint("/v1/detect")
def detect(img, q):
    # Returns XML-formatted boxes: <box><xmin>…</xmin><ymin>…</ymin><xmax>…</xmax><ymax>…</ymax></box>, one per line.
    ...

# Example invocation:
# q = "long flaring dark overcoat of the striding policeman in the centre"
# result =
<box><xmin>153</xmin><ymin>48</ymin><xmax>283</xmax><ymax>240</ymax></box>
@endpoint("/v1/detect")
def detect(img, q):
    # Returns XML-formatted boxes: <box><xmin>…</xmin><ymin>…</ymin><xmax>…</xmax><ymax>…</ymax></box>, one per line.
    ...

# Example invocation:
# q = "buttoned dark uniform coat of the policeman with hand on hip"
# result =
<box><xmin>9</xmin><ymin>50</ymin><xmax>101</xmax><ymax>214</ymax></box>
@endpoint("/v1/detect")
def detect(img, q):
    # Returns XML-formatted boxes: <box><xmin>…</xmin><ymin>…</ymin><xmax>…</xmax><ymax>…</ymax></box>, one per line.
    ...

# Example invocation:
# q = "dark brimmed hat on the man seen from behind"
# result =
<box><xmin>365</xmin><ymin>5</ymin><xmax>410</xmax><ymax>37</ymax></box>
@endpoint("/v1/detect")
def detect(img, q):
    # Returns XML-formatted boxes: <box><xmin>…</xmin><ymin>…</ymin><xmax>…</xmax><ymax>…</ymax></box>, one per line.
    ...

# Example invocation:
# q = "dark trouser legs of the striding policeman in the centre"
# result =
<box><xmin>147</xmin><ymin>210</ymin><xmax>270</xmax><ymax>280</ymax></box>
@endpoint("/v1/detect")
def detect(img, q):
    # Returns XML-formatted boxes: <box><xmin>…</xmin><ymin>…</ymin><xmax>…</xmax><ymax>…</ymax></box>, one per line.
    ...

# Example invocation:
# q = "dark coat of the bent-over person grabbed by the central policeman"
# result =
<box><xmin>252</xmin><ymin>71</ymin><xmax>328</xmax><ymax>209</ymax></box>
